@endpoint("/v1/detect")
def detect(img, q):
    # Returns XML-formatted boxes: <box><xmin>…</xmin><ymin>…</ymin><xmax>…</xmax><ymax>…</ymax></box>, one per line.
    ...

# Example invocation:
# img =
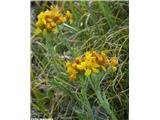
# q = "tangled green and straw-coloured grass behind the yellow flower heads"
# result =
<box><xmin>31</xmin><ymin>1</ymin><xmax>129</xmax><ymax>120</ymax></box>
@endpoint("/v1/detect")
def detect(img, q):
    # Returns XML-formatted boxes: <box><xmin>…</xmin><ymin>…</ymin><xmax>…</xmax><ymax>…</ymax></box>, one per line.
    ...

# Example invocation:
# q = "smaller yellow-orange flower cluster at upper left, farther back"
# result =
<box><xmin>35</xmin><ymin>6</ymin><xmax>72</xmax><ymax>34</ymax></box>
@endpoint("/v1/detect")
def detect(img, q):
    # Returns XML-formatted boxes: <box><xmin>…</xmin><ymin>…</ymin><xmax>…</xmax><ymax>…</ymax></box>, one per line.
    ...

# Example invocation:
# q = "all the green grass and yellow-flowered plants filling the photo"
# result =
<box><xmin>31</xmin><ymin>1</ymin><xmax>129</xmax><ymax>120</ymax></box>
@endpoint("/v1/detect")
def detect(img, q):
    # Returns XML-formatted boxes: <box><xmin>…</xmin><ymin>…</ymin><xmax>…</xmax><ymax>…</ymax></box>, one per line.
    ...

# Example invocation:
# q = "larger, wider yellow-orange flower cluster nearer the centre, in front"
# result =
<box><xmin>66</xmin><ymin>51</ymin><xmax>118</xmax><ymax>80</ymax></box>
